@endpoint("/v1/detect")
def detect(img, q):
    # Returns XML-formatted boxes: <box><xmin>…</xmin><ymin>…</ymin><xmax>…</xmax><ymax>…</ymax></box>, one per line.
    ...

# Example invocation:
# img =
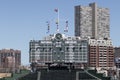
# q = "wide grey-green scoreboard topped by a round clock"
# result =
<box><xmin>29</xmin><ymin>33</ymin><xmax>88</xmax><ymax>67</ymax></box>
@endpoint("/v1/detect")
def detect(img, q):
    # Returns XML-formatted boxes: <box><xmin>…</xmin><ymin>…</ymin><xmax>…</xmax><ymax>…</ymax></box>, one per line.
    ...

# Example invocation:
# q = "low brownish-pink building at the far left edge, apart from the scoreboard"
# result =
<box><xmin>0</xmin><ymin>49</ymin><xmax>21</xmax><ymax>71</ymax></box>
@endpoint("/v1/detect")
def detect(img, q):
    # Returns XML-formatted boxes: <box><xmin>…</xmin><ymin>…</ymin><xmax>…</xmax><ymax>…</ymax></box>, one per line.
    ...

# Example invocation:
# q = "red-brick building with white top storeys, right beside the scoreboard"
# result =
<box><xmin>89</xmin><ymin>39</ymin><xmax>114</xmax><ymax>69</ymax></box>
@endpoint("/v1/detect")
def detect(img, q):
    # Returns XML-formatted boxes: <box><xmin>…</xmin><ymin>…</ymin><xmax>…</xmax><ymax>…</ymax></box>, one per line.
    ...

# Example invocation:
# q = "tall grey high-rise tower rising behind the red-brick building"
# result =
<box><xmin>75</xmin><ymin>3</ymin><xmax>110</xmax><ymax>39</ymax></box>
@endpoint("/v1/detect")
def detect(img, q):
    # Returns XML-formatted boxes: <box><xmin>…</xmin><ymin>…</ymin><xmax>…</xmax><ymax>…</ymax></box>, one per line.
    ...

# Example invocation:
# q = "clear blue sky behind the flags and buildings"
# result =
<box><xmin>0</xmin><ymin>0</ymin><xmax>120</xmax><ymax>64</ymax></box>
